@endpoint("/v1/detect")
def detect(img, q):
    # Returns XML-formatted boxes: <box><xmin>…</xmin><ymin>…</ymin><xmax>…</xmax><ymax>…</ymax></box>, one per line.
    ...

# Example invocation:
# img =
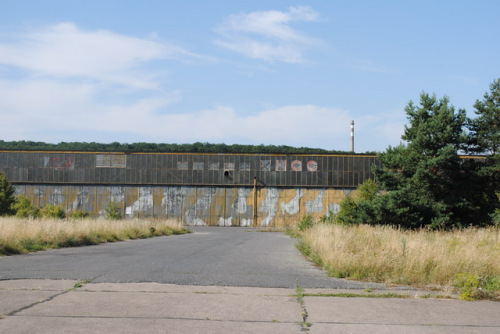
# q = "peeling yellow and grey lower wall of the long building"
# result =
<box><xmin>14</xmin><ymin>184</ymin><xmax>350</xmax><ymax>226</ymax></box>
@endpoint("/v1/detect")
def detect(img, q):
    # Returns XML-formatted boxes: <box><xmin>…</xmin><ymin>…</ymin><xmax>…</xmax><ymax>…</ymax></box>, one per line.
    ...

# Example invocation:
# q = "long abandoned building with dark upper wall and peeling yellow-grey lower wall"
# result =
<box><xmin>0</xmin><ymin>151</ymin><xmax>380</xmax><ymax>226</ymax></box>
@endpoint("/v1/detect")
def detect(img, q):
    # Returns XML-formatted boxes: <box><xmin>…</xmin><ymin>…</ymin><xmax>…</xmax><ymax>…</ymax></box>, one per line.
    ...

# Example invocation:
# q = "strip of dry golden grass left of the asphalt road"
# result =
<box><xmin>0</xmin><ymin>217</ymin><xmax>189</xmax><ymax>255</ymax></box>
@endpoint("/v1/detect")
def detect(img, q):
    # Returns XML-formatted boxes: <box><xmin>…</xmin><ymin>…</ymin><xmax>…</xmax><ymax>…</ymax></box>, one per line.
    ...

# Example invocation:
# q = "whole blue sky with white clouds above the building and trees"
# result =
<box><xmin>0</xmin><ymin>0</ymin><xmax>500</xmax><ymax>152</ymax></box>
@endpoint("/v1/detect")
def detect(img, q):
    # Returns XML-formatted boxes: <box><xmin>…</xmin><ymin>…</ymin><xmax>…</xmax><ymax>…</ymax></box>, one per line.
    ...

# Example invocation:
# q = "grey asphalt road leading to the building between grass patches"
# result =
<box><xmin>0</xmin><ymin>227</ymin><xmax>380</xmax><ymax>289</ymax></box>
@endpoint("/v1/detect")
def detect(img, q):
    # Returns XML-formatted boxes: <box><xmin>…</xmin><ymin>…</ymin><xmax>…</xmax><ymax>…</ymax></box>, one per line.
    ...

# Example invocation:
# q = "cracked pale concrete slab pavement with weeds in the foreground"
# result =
<box><xmin>0</xmin><ymin>280</ymin><xmax>500</xmax><ymax>334</ymax></box>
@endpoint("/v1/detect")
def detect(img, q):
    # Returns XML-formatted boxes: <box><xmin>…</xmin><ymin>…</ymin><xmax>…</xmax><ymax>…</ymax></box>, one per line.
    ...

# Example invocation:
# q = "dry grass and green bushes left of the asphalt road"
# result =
<box><xmin>0</xmin><ymin>172</ymin><xmax>189</xmax><ymax>255</ymax></box>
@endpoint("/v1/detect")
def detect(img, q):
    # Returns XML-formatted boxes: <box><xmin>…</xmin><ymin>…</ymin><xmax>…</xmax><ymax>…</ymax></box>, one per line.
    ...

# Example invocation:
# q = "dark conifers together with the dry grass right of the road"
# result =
<box><xmin>292</xmin><ymin>79</ymin><xmax>500</xmax><ymax>300</ymax></box>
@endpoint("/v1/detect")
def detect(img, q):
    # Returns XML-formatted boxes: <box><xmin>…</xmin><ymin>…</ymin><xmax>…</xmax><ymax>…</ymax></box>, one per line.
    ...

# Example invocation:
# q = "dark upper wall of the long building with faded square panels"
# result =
<box><xmin>0</xmin><ymin>151</ymin><xmax>380</xmax><ymax>188</ymax></box>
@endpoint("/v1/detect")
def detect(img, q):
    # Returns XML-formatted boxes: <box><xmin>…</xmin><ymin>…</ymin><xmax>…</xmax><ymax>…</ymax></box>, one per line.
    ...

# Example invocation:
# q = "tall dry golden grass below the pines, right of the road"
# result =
<box><xmin>299</xmin><ymin>224</ymin><xmax>500</xmax><ymax>294</ymax></box>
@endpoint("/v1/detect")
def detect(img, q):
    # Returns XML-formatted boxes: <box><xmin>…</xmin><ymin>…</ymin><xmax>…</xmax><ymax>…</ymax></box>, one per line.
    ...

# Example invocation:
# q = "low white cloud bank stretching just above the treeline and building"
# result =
<box><xmin>0</xmin><ymin>73</ymin><xmax>404</xmax><ymax>152</ymax></box>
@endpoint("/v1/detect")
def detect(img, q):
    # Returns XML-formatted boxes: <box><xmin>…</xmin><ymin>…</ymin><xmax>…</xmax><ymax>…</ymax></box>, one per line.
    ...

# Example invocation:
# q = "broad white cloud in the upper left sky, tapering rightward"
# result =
<box><xmin>0</xmin><ymin>23</ymin><xmax>199</xmax><ymax>88</ymax></box>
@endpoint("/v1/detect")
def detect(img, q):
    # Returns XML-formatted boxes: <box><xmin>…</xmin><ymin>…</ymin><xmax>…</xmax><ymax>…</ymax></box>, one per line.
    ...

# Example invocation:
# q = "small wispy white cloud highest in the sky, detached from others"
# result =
<box><xmin>215</xmin><ymin>7</ymin><xmax>319</xmax><ymax>63</ymax></box>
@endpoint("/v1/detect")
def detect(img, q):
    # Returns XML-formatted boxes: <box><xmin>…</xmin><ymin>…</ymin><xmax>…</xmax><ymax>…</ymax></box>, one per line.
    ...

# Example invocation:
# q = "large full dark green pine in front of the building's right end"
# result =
<box><xmin>368</xmin><ymin>93</ymin><xmax>485</xmax><ymax>228</ymax></box>
